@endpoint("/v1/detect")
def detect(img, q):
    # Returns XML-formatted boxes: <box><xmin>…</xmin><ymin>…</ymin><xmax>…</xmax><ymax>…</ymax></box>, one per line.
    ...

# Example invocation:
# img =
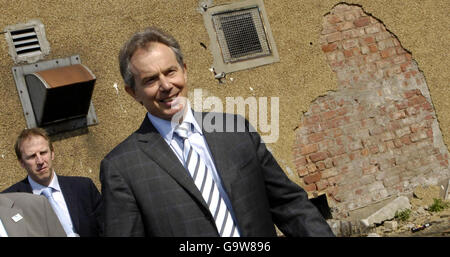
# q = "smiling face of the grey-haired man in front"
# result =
<box><xmin>125</xmin><ymin>42</ymin><xmax>187</xmax><ymax>120</ymax></box>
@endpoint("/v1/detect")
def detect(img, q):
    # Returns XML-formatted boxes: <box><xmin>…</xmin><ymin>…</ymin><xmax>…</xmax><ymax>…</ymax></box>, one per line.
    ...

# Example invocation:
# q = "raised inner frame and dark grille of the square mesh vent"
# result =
<box><xmin>213</xmin><ymin>6</ymin><xmax>270</xmax><ymax>63</ymax></box>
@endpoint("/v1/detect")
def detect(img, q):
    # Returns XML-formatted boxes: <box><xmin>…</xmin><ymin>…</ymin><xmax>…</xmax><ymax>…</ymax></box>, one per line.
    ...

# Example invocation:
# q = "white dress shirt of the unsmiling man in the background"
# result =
<box><xmin>28</xmin><ymin>171</ymin><xmax>79</xmax><ymax>237</ymax></box>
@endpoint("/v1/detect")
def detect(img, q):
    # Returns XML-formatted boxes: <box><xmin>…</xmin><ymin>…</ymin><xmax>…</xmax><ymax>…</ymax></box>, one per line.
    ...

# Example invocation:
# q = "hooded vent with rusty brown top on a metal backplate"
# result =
<box><xmin>12</xmin><ymin>55</ymin><xmax>98</xmax><ymax>135</ymax></box>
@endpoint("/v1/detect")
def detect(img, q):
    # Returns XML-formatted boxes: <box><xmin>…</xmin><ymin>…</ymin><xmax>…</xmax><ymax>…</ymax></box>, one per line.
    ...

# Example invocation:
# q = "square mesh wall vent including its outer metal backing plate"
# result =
<box><xmin>201</xmin><ymin>0</ymin><xmax>279</xmax><ymax>74</ymax></box>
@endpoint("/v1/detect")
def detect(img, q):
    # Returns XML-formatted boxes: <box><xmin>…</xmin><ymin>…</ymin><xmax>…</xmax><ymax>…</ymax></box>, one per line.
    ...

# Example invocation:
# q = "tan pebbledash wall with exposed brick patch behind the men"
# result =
<box><xmin>0</xmin><ymin>0</ymin><xmax>450</xmax><ymax>220</ymax></box>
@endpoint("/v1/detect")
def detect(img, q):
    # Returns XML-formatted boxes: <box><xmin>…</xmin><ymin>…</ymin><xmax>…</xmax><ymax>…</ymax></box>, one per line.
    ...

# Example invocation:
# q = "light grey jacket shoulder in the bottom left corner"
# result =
<box><xmin>0</xmin><ymin>193</ymin><xmax>66</xmax><ymax>237</ymax></box>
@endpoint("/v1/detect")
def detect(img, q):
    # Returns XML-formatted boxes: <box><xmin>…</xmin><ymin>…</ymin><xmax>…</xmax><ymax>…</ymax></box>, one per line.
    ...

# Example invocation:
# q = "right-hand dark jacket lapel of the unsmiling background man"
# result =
<box><xmin>58</xmin><ymin>176</ymin><xmax>80</xmax><ymax>233</ymax></box>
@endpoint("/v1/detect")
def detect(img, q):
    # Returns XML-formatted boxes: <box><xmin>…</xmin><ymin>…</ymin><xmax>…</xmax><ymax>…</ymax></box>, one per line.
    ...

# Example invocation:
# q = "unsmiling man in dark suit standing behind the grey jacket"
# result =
<box><xmin>3</xmin><ymin>128</ymin><xmax>103</xmax><ymax>237</ymax></box>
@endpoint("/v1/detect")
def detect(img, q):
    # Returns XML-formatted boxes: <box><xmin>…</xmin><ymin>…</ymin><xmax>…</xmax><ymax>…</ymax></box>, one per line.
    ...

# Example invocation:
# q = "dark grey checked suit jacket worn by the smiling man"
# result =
<box><xmin>100</xmin><ymin>114</ymin><xmax>333</xmax><ymax>237</ymax></box>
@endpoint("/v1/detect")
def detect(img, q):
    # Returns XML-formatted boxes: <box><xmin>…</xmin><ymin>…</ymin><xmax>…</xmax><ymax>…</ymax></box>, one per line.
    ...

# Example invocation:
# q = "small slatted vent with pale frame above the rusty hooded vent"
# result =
<box><xmin>5</xmin><ymin>20</ymin><xmax>50</xmax><ymax>63</ymax></box>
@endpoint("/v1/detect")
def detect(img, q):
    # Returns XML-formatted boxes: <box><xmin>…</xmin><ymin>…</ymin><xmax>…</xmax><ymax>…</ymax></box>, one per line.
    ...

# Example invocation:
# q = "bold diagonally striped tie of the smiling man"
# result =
<box><xmin>175</xmin><ymin>122</ymin><xmax>239</xmax><ymax>237</ymax></box>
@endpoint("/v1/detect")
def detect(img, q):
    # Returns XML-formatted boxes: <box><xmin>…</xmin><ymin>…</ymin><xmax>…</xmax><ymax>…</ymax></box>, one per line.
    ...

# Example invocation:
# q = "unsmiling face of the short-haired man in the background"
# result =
<box><xmin>19</xmin><ymin>135</ymin><xmax>55</xmax><ymax>186</ymax></box>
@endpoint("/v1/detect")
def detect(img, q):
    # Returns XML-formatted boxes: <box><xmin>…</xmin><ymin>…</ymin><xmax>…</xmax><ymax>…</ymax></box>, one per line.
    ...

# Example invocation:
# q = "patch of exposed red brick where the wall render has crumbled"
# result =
<box><xmin>294</xmin><ymin>4</ymin><xmax>450</xmax><ymax>218</ymax></box>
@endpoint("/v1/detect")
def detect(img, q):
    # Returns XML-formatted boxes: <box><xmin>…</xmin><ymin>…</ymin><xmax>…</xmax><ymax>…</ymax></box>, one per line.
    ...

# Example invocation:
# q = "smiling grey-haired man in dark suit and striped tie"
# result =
<box><xmin>100</xmin><ymin>28</ymin><xmax>334</xmax><ymax>237</ymax></box>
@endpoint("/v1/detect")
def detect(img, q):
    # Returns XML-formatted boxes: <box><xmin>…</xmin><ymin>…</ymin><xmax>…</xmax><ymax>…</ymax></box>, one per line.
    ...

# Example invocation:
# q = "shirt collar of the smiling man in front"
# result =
<box><xmin>147</xmin><ymin>102</ymin><xmax>203</xmax><ymax>142</ymax></box>
